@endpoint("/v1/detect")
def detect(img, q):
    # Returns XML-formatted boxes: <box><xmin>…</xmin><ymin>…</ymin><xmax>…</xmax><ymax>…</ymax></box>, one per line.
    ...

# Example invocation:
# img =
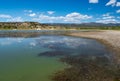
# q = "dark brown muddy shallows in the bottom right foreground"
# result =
<box><xmin>52</xmin><ymin>55</ymin><xmax>120</xmax><ymax>81</ymax></box>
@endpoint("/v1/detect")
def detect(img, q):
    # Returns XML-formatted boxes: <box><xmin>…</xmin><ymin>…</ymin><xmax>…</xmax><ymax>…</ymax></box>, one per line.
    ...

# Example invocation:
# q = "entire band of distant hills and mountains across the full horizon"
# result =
<box><xmin>0</xmin><ymin>22</ymin><xmax>120</xmax><ymax>30</ymax></box>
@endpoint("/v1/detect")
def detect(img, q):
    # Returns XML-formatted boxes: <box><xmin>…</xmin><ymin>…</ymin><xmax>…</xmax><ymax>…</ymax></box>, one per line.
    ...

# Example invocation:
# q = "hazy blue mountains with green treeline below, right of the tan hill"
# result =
<box><xmin>46</xmin><ymin>22</ymin><xmax>120</xmax><ymax>30</ymax></box>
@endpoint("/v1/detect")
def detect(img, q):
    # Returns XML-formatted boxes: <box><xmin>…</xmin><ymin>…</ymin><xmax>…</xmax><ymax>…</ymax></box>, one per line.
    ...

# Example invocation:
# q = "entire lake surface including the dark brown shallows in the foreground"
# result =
<box><xmin>0</xmin><ymin>31</ymin><xmax>120</xmax><ymax>81</ymax></box>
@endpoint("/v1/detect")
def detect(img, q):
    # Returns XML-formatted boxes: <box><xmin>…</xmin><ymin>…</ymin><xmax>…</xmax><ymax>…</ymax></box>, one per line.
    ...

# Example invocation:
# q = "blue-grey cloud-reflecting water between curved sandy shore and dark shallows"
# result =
<box><xmin>36</xmin><ymin>36</ymin><xmax>108</xmax><ymax>55</ymax></box>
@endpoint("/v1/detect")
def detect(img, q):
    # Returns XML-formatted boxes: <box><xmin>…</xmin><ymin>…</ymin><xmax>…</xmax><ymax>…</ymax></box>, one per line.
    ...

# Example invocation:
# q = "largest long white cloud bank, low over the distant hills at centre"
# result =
<box><xmin>33</xmin><ymin>12</ymin><xmax>92</xmax><ymax>23</ymax></box>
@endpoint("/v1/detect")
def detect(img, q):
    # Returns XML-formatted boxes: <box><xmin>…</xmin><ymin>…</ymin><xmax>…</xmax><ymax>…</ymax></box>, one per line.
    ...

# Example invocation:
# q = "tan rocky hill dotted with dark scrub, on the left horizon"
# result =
<box><xmin>0</xmin><ymin>22</ymin><xmax>48</xmax><ymax>29</ymax></box>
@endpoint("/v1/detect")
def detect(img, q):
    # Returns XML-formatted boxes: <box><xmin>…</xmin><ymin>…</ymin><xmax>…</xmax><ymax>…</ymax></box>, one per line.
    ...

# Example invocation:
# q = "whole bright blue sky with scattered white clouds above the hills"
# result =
<box><xmin>0</xmin><ymin>0</ymin><xmax>120</xmax><ymax>24</ymax></box>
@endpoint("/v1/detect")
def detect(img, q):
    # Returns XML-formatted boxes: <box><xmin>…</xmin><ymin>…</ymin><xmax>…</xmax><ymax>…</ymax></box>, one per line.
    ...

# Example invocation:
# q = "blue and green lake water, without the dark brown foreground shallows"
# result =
<box><xmin>0</xmin><ymin>31</ymin><xmax>111</xmax><ymax>81</ymax></box>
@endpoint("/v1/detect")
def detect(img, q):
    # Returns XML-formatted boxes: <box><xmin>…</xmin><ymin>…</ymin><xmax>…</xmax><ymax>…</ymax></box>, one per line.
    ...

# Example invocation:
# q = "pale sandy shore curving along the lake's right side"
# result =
<box><xmin>70</xmin><ymin>30</ymin><xmax>120</xmax><ymax>63</ymax></box>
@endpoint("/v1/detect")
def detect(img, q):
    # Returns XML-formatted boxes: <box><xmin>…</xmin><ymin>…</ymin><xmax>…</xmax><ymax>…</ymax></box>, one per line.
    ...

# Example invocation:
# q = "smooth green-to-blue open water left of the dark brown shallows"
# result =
<box><xmin>0</xmin><ymin>38</ymin><xmax>65</xmax><ymax>81</ymax></box>
